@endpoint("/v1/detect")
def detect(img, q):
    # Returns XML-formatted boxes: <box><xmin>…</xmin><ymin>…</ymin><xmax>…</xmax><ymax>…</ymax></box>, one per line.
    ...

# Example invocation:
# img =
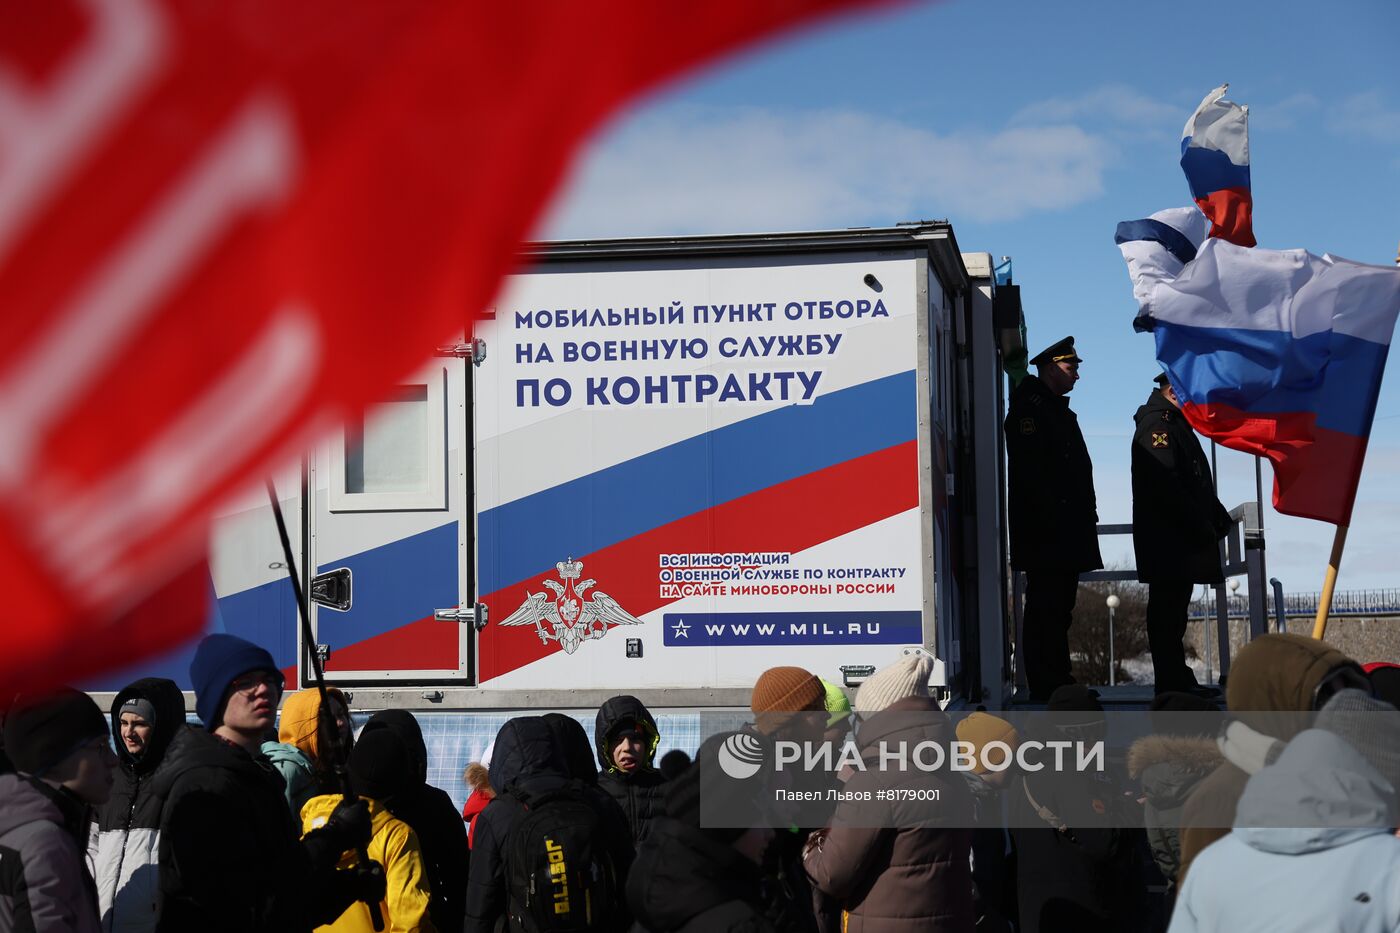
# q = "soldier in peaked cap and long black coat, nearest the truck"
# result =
<box><xmin>1007</xmin><ymin>336</ymin><xmax>1103</xmax><ymax>702</ymax></box>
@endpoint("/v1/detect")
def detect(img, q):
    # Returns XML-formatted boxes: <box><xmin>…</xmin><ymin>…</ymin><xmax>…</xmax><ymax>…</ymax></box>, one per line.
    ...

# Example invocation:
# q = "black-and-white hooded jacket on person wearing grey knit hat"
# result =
<box><xmin>88</xmin><ymin>678</ymin><xmax>192</xmax><ymax>933</ymax></box>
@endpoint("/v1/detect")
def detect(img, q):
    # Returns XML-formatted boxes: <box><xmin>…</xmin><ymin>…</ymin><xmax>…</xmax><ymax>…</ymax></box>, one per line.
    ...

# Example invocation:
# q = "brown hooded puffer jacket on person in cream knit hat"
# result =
<box><xmin>805</xmin><ymin>696</ymin><xmax>973</xmax><ymax>933</ymax></box>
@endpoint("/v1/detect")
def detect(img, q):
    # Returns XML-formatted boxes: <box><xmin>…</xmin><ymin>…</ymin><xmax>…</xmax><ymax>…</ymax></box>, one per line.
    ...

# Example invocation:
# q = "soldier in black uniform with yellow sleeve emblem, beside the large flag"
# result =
<box><xmin>1133</xmin><ymin>374</ymin><xmax>1231</xmax><ymax>695</ymax></box>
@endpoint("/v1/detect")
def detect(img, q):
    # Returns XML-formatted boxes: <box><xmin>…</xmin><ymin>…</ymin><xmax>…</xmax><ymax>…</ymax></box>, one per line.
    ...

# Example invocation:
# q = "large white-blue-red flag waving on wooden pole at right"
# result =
<box><xmin>1116</xmin><ymin>209</ymin><xmax>1400</xmax><ymax>525</ymax></box>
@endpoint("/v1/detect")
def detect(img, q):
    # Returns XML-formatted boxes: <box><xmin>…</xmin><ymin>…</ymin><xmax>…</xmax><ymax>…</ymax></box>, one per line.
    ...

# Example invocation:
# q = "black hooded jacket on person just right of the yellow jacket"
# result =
<box><xmin>360</xmin><ymin>709</ymin><xmax>472</xmax><ymax>933</ymax></box>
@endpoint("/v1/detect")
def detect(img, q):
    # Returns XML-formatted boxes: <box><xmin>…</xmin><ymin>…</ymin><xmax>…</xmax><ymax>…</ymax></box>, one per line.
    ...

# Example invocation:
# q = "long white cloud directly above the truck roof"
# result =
<box><xmin>546</xmin><ymin>106</ymin><xmax>1113</xmax><ymax>237</ymax></box>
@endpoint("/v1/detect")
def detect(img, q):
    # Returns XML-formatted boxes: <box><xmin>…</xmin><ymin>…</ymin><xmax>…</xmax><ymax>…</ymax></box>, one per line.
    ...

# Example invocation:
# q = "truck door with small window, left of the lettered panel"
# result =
<box><xmin>308</xmin><ymin>342</ymin><xmax>475</xmax><ymax>684</ymax></box>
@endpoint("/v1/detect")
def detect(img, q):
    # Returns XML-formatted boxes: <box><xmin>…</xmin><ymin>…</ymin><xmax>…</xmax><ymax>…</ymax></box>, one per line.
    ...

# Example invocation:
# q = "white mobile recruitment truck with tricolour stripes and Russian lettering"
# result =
<box><xmin>87</xmin><ymin>223</ymin><xmax>1019</xmax><ymax>767</ymax></box>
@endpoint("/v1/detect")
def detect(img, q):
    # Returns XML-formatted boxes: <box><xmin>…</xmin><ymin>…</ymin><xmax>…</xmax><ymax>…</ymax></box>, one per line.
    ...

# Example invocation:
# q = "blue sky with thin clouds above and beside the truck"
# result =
<box><xmin>540</xmin><ymin>0</ymin><xmax>1400</xmax><ymax>591</ymax></box>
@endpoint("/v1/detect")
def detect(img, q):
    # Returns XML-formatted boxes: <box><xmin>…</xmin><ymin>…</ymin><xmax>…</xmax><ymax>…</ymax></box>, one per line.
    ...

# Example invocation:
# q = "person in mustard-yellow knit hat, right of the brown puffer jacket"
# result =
<box><xmin>956</xmin><ymin>709</ymin><xmax>1021</xmax><ymax>933</ymax></box>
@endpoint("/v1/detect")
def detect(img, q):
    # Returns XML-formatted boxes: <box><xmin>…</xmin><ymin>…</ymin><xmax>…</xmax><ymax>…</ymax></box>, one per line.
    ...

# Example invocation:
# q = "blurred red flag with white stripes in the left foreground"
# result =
<box><xmin>0</xmin><ymin>0</ymin><xmax>890</xmax><ymax>686</ymax></box>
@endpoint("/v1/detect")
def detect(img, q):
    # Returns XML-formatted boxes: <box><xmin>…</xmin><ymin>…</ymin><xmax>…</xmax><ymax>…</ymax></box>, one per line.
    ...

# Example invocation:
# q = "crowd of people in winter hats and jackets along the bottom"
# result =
<box><xmin>0</xmin><ymin>635</ymin><xmax>1400</xmax><ymax>933</ymax></box>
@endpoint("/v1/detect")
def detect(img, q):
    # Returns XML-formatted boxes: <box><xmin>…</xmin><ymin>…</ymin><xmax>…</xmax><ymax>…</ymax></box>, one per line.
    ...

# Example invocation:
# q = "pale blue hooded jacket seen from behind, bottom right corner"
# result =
<box><xmin>1170</xmin><ymin>728</ymin><xmax>1400</xmax><ymax>933</ymax></box>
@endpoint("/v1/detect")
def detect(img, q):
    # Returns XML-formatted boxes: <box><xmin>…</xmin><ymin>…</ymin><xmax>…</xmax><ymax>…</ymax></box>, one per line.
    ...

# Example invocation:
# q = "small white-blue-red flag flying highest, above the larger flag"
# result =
<box><xmin>1182</xmin><ymin>84</ymin><xmax>1254</xmax><ymax>247</ymax></box>
